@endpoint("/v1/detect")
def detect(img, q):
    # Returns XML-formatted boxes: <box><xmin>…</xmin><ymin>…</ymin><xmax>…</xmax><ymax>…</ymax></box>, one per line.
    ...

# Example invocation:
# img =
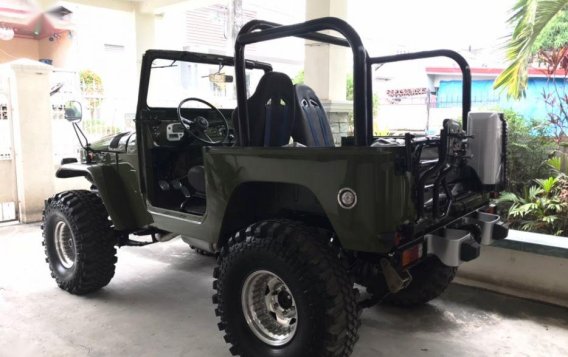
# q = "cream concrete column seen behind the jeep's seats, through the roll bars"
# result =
<box><xmin>304</xmin><ymin>0</ymin><xmax>353</xmax><ymax>144</ymax></box>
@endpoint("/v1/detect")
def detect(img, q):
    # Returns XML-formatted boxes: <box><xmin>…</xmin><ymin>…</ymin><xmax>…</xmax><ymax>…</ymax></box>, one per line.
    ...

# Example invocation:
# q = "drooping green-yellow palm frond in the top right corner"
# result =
<box><xmin>493</xmin><ymin>0</ymin><xmax>568</xmax><ymax>98</ymax></box>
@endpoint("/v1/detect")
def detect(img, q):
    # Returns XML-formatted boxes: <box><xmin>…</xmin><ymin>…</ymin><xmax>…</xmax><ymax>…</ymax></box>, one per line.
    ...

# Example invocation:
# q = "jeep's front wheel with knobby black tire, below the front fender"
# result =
<box><xmin>42</xmin><ymin>191</ymin><xmax>116</xmax><ymax>294</ymax></box>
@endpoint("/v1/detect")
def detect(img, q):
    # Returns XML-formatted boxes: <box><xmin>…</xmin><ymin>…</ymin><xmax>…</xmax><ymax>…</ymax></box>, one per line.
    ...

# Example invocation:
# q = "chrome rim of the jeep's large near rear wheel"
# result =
<box><xmin>241</xmin><ymin>270</ymin><xmax>298</xmax><ymax>346</ymax></box>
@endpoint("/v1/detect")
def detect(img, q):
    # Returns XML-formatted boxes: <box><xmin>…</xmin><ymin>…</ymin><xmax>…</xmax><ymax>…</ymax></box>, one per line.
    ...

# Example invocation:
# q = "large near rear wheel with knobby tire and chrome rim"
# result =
<box><xmin>213</xmin><ymin>221</ymin><xmax>359</xmax><ymax>357</ymax></box>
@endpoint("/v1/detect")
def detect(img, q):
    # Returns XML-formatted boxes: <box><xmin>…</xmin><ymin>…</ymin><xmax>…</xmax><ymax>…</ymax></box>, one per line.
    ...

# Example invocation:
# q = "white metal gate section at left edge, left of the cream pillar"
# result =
<box><xmin>0</xmin><ymin>72</ymin><xmax>18</xmax><ymax>222</ymax></box>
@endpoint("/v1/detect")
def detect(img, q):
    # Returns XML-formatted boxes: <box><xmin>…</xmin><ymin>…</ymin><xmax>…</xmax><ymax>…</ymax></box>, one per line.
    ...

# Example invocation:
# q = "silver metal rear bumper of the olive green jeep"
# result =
<box><xmin>424</xmin><ymin>208</ymin><xmax>509</xmax><ymax>267</ymax></box>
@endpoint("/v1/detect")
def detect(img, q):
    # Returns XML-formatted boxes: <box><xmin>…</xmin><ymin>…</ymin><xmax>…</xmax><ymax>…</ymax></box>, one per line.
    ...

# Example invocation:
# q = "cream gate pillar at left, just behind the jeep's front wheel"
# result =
<box><xmin>8</xmin><ymin>60</ymin><xmax>54</xmax><ymax>223</ymax></box>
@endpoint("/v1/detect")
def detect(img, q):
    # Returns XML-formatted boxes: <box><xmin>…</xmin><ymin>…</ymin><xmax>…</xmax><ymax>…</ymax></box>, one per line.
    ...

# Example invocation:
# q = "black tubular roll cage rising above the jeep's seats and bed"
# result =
<box><xmin>235</xmin><ymin>17</ymin><xmax>471</xmax><ymax>146</ymax></box>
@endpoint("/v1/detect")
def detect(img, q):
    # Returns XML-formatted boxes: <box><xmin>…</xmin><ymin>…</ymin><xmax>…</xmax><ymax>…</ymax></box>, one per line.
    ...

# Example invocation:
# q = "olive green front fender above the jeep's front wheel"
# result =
<box><xmin>55</xmin><ymin>162</ymin><xmax>153</xmax><ymax>231</ymax></box>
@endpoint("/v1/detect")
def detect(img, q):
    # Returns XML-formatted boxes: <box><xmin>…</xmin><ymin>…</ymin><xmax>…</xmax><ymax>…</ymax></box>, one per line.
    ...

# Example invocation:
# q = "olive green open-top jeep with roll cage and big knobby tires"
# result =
<box><xmin>42</xmin><ymin>18</ymin><xmax>508</xmax><ymax>356</ymax></box>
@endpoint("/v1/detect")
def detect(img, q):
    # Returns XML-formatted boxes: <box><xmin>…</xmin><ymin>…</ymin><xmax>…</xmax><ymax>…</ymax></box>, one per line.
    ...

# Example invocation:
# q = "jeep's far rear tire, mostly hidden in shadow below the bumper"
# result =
<box><xmin>383</xmin><ymin>256</ymin><xmax>458</xmax><ymax>307</ymax></box>
